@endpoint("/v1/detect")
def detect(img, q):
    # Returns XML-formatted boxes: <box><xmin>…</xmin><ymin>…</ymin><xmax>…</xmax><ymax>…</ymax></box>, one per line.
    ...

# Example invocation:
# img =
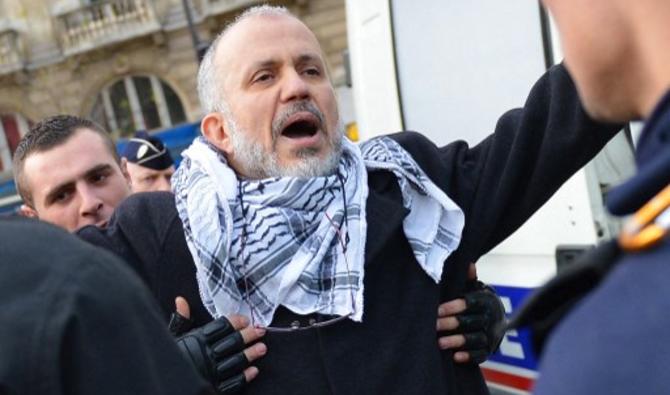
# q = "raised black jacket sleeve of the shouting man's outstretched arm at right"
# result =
<box><xmin>394</xmin><ymin>65</ymin><xmax>621</xmax><ymax>294</ymax></box>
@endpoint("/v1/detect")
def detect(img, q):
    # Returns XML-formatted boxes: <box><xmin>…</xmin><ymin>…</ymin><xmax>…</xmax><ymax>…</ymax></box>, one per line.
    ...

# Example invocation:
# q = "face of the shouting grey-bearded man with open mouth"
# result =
<box><xmin>203</xmin><ymin>16</ymin><xmax>342</xmax><ymax>178</ymax></box>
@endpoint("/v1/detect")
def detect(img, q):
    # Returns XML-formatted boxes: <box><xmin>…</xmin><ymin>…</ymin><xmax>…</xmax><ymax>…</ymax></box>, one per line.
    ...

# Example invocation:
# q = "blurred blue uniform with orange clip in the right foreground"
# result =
<box><xmin>515</xmin><ymin>93</ymin><xmax>670</xmax><ymax>395</ymax></box>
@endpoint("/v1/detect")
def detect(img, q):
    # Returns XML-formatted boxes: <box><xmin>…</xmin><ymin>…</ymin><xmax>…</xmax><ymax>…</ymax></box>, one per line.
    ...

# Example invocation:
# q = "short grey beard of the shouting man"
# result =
<box><xmin>226</xmin><ymin>116</ymin><xmax>344</xmax><ymax>179</ymax></box>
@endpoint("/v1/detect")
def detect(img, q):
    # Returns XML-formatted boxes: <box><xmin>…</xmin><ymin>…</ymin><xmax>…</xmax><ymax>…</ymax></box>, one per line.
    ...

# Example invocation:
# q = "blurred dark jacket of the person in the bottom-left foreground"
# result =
<box><xmin>0</xmin><ymin>218</ymin><xmax>213</xmax><ymax>395</ymax></box>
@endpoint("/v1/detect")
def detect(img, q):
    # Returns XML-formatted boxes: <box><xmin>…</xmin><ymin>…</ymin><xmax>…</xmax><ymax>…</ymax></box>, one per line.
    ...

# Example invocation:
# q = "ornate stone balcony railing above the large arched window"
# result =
<box><xmin>56</xmin><ymin>0</ymin><xmax>160</xmax><ymax>56</ymax></box>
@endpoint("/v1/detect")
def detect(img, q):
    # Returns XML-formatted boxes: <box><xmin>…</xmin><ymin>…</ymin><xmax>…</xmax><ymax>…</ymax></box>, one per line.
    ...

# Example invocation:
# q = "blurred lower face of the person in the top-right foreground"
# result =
<box><xmin>543</xmin><ymin>0</ymin><xmax>641</xmax><ymax>121</ymax></box>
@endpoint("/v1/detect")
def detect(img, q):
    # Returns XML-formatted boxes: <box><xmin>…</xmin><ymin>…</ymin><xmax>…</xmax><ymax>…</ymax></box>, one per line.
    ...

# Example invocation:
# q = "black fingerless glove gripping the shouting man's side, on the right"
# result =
<box><xmin>453</xmin><ymin>280</ymin><xmax>506</xmax><ymax>364</ymax></box>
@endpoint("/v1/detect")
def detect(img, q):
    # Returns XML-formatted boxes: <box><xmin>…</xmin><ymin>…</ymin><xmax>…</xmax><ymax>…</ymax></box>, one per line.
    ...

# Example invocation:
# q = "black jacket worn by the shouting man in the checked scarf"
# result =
<box><xmin>81</xmin><ymin>67</ymin><xmax>618</xmax><ymax>394</ymax></box>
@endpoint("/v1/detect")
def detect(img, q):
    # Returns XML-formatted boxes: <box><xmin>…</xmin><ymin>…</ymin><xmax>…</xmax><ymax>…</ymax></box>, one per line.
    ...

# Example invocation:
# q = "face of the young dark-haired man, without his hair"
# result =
<box><xmin>23</xmin><ymin>128</ymin><xmax>130</xmax><ymax>232</ymax></box>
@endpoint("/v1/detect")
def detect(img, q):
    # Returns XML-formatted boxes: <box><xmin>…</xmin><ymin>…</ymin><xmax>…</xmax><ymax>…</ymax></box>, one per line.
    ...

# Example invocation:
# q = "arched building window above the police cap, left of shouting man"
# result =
<box><xmin>90</xmin><ymin>75</ymin><xmax>186</xmax><ymax>137</ymax></box>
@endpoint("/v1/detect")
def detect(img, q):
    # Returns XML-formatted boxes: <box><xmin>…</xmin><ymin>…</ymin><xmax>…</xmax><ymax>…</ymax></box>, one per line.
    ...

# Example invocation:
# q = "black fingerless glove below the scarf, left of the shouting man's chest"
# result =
<box><xmin>169</xmin><ymin>313</ymin><xmax>249</xmax><ymax>395</ymax></box>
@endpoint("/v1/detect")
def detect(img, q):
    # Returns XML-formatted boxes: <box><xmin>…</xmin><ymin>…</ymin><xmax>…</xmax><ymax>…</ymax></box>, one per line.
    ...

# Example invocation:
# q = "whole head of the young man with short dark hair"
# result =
<box><xmin>13</xmin><ymin>115</ymin><xmax>130</xmax><ymax>232</ymax></box>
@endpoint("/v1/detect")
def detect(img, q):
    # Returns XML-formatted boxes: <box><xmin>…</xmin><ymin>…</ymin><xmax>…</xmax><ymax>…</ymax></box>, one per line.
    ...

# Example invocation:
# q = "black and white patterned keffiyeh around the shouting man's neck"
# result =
<box><xmin>172</xmin><ymin>137</ymin><xmax>464</xmax><ymax>326</ymax></box>
